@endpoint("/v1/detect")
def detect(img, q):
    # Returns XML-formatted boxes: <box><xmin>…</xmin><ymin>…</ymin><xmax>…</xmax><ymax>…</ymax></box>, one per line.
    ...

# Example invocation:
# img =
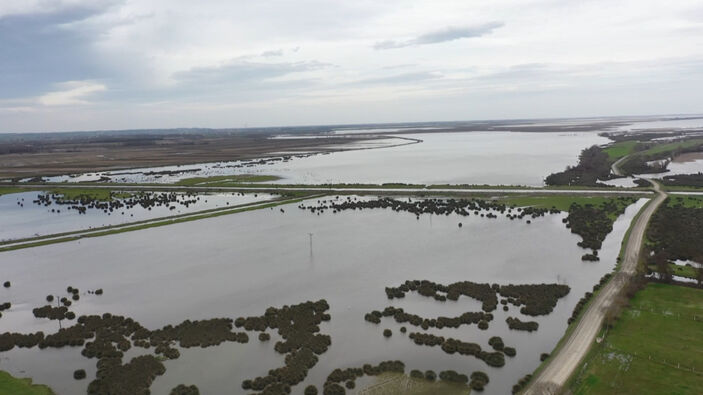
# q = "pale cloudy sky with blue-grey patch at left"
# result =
<box><xmin>0</xmin><ymin>0</ymin><xmax>703</xmax><ymax>132</ymax></box>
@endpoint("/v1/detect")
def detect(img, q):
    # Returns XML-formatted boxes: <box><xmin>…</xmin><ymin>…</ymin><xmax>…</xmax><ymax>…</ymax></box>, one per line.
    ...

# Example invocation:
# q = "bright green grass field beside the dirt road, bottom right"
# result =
<box><xmin>572</xmin><ymin>284</ymin><xmax>703</xmax><ymax>395</ymax></box>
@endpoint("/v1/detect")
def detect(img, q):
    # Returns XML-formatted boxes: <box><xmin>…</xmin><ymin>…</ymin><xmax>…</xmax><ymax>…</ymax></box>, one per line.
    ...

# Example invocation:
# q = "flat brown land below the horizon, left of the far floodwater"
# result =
<box><xmin>0</xmin><ymin>132</ymin><xmax>368</xmax><ymax>178</ymax></box>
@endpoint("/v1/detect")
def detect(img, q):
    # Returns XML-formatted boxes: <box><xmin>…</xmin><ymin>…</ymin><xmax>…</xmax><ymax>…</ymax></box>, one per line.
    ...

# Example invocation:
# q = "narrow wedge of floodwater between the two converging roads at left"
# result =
<box><xmin>0</xmin><ymin>191</ymin><xmax>274</xmax><ymax>241</ymax></box>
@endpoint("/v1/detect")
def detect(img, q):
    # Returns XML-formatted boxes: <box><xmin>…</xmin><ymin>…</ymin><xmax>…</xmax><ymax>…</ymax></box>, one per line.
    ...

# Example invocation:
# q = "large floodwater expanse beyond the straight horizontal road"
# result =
<box><xmin>41</xmin><ymin>132</ymin><xmax>610</xmax><ymax>186</ymax></box>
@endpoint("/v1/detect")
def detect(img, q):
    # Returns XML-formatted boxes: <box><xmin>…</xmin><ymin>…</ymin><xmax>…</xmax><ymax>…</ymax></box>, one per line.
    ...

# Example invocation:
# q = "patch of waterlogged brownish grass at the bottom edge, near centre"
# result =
<box><xmin>359</xmin><ymin>373</ymin><xmax>472</xmax><ymax>395</ymax></box>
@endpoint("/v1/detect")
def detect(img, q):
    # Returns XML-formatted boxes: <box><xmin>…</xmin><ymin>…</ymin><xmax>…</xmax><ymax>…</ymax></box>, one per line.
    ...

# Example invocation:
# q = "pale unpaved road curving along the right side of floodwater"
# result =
<box><xmin>524</xmin><ymin>180</ymin><xmax>667</xmax><ymax>395</ymax></box>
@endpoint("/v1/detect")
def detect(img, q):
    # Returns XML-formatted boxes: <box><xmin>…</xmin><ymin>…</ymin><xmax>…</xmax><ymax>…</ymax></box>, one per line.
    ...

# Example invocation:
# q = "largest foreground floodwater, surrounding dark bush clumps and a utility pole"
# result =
<box><xmin>0</xmin><ymin>199</ymin><xmax>645</xmax><ymax>395</ymax></box>
